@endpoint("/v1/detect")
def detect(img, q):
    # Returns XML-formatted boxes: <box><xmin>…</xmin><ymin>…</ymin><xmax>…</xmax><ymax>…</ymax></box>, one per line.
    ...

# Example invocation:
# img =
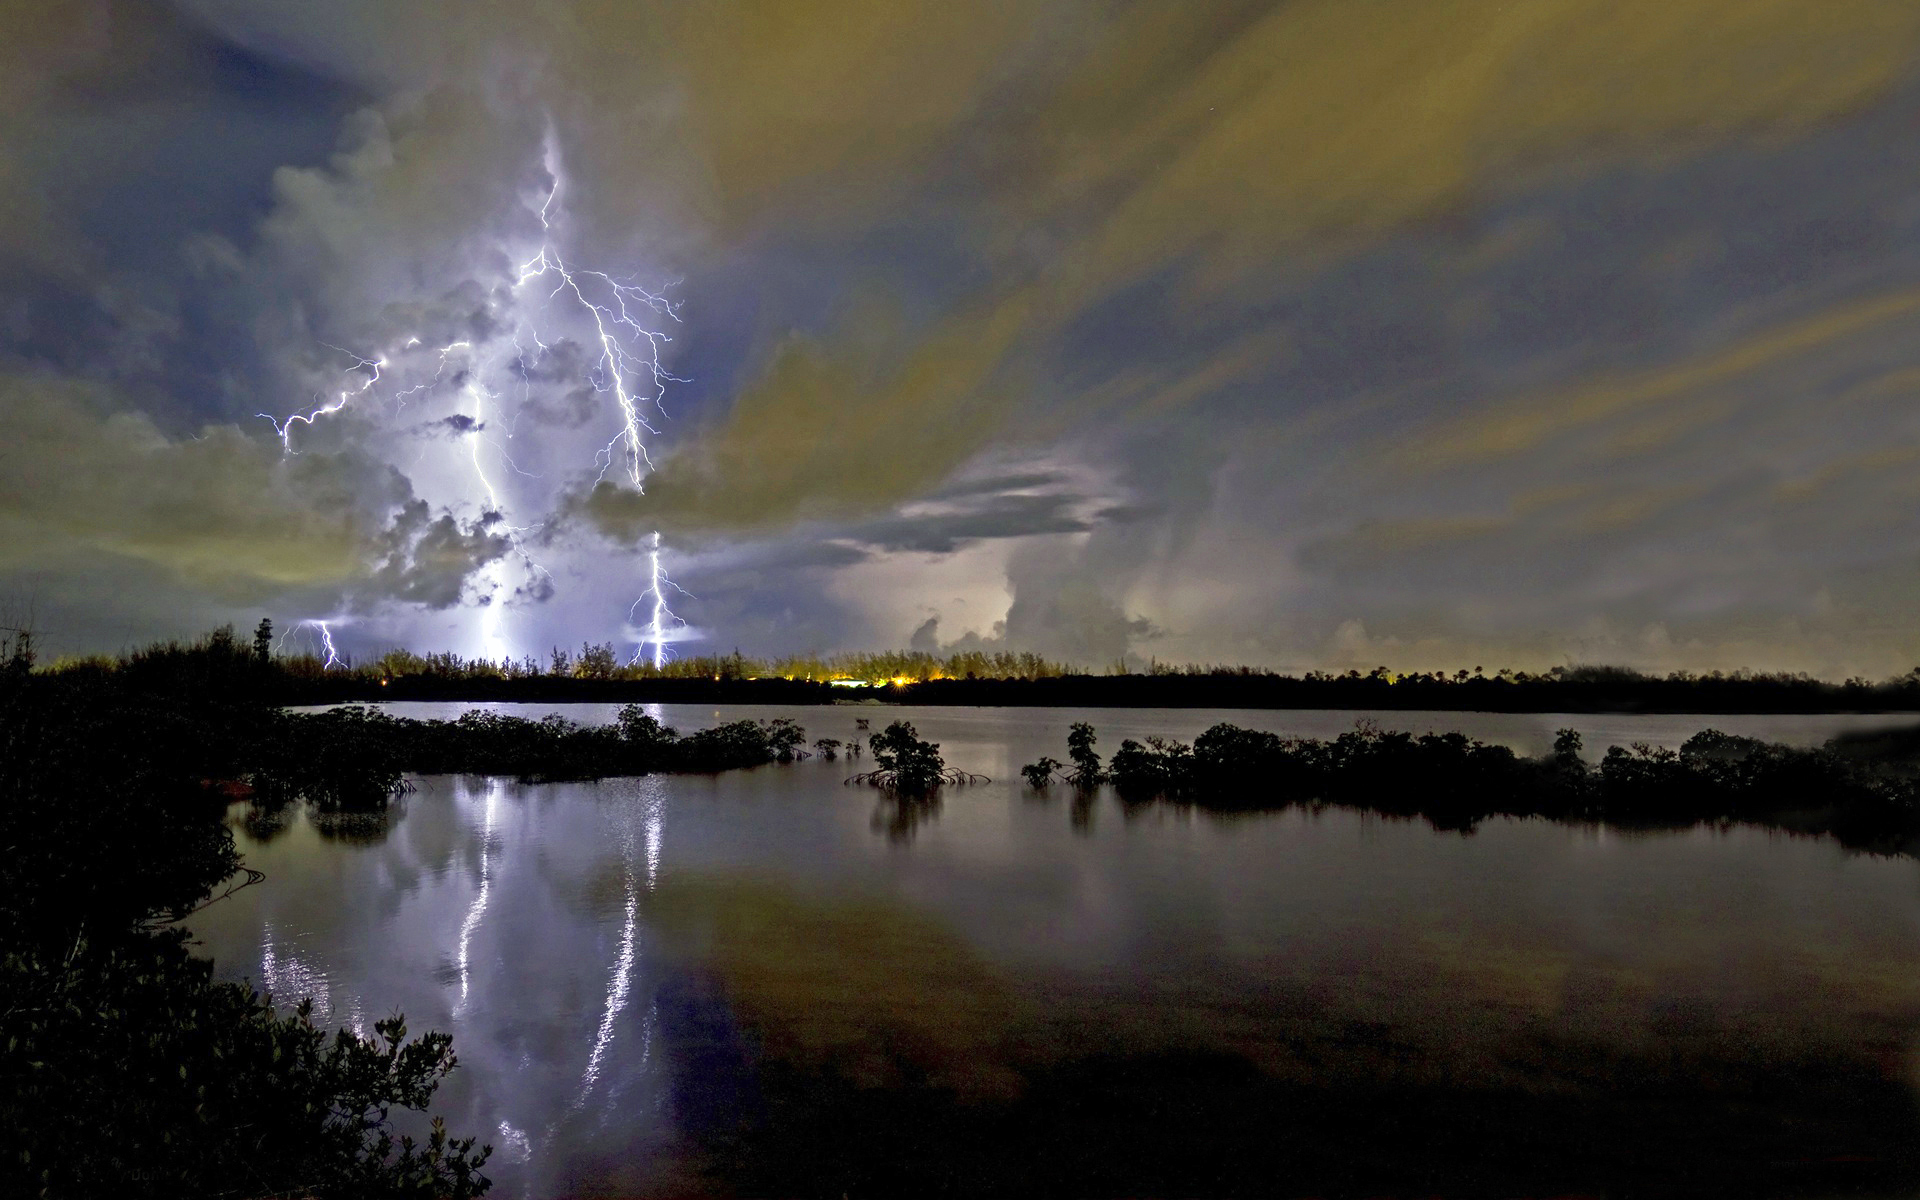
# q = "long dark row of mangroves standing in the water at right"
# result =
<box><xmin>1025</xmin><ymin>724</ymin><xmax>1920</xmax><ymax>851</ymax></box>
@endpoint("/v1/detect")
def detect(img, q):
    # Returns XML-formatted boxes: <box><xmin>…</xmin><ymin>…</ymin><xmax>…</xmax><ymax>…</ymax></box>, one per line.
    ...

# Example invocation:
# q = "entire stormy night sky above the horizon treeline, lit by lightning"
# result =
<box><xmin>0</xmin><ymin>0</ymin><xmax>1920</xmax><ymax>676</ymax></box>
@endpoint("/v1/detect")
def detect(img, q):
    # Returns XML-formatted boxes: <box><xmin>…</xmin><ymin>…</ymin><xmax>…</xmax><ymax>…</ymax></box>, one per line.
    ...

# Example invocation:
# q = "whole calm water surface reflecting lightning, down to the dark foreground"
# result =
<box><xmin>192</xmin><ymin>705</ymin><xmax>1920</xmax><ymax>1196</ymax></box>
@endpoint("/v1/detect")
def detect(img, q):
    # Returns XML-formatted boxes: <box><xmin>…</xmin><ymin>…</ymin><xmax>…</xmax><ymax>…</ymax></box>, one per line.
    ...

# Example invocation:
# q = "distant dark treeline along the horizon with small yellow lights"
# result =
<box><xmin>135</xmin><ymin>620</ymin><xmax>1920</xmax><ymax>712</ymax></box>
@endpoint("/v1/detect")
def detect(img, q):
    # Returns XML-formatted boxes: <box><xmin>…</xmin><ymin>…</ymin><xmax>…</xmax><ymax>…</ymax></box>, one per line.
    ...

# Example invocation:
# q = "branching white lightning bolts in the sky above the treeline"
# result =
<box><xmin>261</xmin><ymin>120</ymin><xmax>689</xmax><ymax>668</ymax></box>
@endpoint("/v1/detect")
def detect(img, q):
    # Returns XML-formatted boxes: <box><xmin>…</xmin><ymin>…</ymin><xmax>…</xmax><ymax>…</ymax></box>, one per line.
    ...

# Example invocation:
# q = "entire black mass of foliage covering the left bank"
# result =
<box><xmin>0</xmin><ymin>634</ymin><xmax>488</xmax><ymax>1196</ymax></box>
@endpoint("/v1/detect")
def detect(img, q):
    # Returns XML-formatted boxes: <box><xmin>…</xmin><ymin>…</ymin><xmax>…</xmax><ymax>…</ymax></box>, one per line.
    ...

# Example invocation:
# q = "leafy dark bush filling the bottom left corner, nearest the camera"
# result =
<box><xmin>0</xmin><ymin>935</ymin><xmax>488</xmax><ymax>1198</ymax></box>
